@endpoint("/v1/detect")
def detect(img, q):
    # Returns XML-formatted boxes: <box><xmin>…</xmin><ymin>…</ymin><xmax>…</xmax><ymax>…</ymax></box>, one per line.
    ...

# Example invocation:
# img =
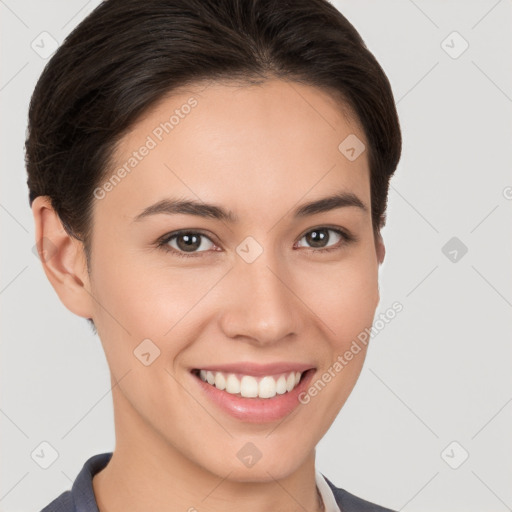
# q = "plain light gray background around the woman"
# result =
<box><xmin>0</xmin><ymin>0</ymin><xmax>512</xmax><ymax>512</ymax></box>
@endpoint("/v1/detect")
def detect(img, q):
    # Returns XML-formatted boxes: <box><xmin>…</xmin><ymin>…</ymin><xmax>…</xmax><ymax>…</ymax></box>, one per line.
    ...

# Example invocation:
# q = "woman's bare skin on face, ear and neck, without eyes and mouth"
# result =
<box><xmin>32</xmin><ymin>80</ymin><xmax>385</xmax><ymax>512</ymax></box>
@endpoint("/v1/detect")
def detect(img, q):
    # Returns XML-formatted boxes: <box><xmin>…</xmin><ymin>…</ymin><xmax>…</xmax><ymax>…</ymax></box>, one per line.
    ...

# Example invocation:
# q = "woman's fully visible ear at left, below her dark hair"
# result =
<box><xmin>32</xmin><ymin>196</ymin><xmax>93</xmax><ymax>318</ymax></box>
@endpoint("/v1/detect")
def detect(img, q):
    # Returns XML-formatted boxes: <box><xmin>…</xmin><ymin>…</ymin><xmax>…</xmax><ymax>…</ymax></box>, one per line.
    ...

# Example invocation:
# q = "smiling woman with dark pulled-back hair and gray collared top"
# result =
<box><xmin>26</xmin><ymin>0</ymin><xmax>401</xmax><ymax>512</ymax></box>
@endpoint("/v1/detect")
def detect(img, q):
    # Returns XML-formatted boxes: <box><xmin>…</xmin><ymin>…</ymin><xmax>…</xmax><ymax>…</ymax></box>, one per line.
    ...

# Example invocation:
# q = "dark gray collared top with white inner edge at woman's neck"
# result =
<box><xmin>41</xmin><ymin>452</ymin><xmax>394</xmax><ymax>512</ymax></box>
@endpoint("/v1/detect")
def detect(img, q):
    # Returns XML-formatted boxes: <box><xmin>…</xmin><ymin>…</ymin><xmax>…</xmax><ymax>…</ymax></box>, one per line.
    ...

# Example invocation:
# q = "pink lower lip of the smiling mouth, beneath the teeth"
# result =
<box><xmin>192</xmin><ymin>369</ymin><xmax>315</xmax><ymax>423</ymax></box>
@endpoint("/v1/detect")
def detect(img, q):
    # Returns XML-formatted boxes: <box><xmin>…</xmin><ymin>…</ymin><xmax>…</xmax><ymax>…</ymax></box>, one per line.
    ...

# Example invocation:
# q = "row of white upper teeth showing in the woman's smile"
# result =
<box><xmin>199</xmin><ymin>370</ymin><xmax>302</xmax><ymax>398</ymax></box>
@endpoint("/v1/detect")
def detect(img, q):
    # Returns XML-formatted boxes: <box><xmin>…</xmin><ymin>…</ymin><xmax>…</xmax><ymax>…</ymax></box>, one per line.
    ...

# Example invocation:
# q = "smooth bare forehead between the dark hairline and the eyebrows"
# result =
<box><xmin>100</xmin><ymin>80</ymin><xmax>369</xmax><ymax>222</ymax></box>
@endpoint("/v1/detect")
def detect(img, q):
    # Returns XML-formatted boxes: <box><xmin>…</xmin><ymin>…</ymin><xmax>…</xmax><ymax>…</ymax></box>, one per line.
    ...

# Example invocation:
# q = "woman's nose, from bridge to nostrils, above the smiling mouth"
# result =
<box><xmin>220</xmin><ymin>251</ymin><xmax>305</xmax><ymax>345</ymax></box>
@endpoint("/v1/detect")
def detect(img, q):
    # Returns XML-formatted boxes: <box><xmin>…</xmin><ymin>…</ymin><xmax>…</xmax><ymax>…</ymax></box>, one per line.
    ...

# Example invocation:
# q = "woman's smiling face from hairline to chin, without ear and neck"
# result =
<box><xmin>47</xmin><ymin>80</ymin><xmax>379</xmax><ymax>481</ymax></box>
